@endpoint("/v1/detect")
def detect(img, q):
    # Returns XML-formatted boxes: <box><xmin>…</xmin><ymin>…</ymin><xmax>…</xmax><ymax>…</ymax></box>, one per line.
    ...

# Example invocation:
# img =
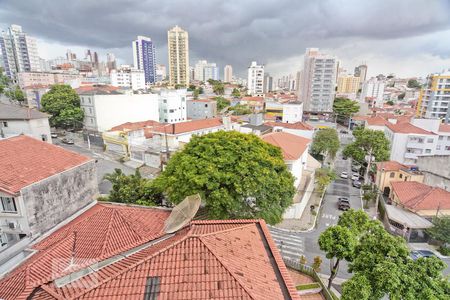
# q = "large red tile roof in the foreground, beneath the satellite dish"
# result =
<box><xmin>0</xmin><ymin>204</ymin><xmax>300</xmax><ymax>300</ymax></box>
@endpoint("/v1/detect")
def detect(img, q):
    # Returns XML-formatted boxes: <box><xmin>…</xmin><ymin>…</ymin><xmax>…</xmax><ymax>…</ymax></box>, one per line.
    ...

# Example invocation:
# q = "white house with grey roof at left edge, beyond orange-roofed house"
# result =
<box><xmin>0</xmin><ymin>103</ymin><xmax>52</xmax><ymax>143</ymax></box>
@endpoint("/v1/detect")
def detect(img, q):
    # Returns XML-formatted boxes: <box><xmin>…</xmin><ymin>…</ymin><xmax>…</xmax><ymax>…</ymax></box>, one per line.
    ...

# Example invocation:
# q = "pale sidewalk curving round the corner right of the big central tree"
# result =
<box><xmin>275</xmin><ymin>191</ymin><xmax>322</xmax><ymax>232</ymax></box>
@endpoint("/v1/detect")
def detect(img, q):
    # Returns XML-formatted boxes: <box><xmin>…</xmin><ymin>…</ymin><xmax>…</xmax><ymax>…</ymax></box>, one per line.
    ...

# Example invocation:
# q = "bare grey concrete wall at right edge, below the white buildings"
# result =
<box><xmin>417</xmin><ymin>155</ymin><xmax>450</xmax><ymax>191</ymax></box>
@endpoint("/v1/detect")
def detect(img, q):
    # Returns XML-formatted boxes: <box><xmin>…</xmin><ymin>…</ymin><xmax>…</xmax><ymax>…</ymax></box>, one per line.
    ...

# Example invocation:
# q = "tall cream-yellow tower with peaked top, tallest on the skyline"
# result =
<box><xmin>167</xmin><ymin>26</ymin><xmax>189</xmax><ymax>86</ymax></box>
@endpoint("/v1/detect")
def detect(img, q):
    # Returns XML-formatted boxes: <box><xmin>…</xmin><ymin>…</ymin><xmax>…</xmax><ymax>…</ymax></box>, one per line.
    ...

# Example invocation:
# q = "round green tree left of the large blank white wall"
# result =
<box><xmin>41</xmin><ymin>84</ymin><xmax>84</xmax><ymax>128</ymax></box>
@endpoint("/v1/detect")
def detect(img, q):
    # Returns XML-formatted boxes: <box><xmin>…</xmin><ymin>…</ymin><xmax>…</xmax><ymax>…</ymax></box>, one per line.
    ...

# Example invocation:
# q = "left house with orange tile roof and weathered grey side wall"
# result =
<box><xmin>0</xmin><ymin>135</ymin><xmax>98</xmax><ymax>270</ymax></box>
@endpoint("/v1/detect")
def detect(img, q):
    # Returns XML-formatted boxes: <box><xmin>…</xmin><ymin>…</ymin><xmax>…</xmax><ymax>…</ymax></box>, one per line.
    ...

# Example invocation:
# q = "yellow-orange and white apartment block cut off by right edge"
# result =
<box><xmin>417</xmin><ymin>69</ymin><xmax>450</xmax><ymax>123</ymax></box>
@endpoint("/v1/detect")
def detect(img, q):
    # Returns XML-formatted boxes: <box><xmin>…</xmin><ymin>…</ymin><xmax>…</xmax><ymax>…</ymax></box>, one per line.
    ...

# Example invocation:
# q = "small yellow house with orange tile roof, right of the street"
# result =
<box><xmin>375</xmin><ymin>160</ymin><xmax>424</xmax><ymax>196</ymax></box>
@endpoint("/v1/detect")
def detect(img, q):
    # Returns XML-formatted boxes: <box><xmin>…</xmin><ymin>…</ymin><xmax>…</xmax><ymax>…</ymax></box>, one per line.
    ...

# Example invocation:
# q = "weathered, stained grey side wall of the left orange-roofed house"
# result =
<box><xmin>21</xmin><ymin>160</ymin><xmax>98</xmax><ymax>238</ymax></box>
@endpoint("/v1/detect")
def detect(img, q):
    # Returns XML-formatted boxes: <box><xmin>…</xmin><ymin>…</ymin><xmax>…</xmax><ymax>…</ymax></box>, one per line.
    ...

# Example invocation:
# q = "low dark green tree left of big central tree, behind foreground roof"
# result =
<box><xmin>104</xmin><ymin>169</ymin><xmax>163</xmax><ymax>206</ymax></box>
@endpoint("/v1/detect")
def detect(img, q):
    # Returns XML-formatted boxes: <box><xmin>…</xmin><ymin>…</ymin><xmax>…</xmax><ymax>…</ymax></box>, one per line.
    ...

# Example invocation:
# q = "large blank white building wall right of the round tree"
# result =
<box><xmin>94</xmin><ymin>94</ymin><xmax>159</xmax><ymax>132</ymax></box>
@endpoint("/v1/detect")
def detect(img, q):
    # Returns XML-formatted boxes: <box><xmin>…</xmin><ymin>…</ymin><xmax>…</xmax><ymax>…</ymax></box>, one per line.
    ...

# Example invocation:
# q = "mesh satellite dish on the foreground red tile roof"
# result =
<box><xmin>164</xmin><ymin>194</ymin><xmax>202</xmax><ymax>233</ymax></box>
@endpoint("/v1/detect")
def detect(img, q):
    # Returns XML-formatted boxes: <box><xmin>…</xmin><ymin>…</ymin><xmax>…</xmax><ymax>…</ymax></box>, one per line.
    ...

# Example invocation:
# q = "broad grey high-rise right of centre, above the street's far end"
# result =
<box><xmin>300</xmin><ymin>48</ymin><xmax>338</xmax><ymax>113</ymax></box>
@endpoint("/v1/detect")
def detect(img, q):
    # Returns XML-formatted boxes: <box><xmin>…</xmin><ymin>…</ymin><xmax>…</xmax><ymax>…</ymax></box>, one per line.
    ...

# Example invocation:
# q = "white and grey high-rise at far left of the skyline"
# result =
<box><xmin>0</xmin><ymin>25</ymin><xmax>40</xmax><ymax>79</ymax></box>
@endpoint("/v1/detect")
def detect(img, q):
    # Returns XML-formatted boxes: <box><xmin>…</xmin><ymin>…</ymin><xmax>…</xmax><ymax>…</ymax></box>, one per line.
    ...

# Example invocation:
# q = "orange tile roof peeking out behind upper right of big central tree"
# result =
<box><xmin>261</xmin><ymin>132</ymin><xmax>311</xmax><ymax>160</ymax></box>
